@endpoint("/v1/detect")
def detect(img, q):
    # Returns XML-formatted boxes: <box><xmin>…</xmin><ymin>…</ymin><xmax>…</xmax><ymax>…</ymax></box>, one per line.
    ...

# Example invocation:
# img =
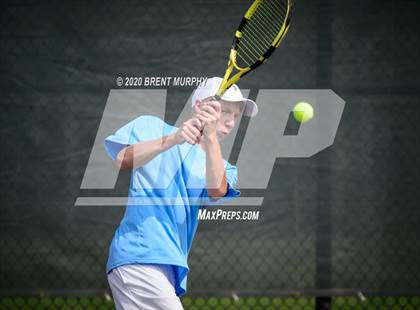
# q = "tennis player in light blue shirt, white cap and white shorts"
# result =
<box><xmin>105</xmin><ymin>77</ymin><xmax>258</xmax><ymax>310</ymax></box>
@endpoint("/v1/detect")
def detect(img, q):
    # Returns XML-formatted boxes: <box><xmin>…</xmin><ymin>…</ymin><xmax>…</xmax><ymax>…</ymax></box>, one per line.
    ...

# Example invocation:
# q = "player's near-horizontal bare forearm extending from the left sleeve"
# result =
<box><xmin>117</xmin><ymin>134</ymin><xmax>177</xmax><ymax>170</ymax></box>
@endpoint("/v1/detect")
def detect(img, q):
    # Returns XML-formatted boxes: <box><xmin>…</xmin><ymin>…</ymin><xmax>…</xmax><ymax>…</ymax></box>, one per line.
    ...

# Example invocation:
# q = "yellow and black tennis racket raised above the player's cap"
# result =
<box><xmin>213</xmin><ymin>0</ymin><xmax>292</xmax><ymax>100</ymax></box>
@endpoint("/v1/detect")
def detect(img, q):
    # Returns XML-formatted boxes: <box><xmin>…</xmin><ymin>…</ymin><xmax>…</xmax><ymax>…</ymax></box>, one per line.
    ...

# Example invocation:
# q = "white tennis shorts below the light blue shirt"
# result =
<box><xmin>108</xmin><ymin>264</ymin><xmax>184</xmax><ymax>310</ymax></box>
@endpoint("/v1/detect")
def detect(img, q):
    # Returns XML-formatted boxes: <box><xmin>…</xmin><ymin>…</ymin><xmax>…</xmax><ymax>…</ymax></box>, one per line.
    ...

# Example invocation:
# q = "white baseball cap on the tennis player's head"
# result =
<box><xmin>191</xmin><ymin>77</ymin><xmax>258</xmax><ymax>117</ymax></box>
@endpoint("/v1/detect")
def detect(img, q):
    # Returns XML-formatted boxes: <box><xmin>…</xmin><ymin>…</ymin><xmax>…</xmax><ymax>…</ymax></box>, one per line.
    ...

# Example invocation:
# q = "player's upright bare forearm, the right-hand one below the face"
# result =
<box><xmin>204</xmin><ymin>136</ymin><xmax>227</xmax><ymax>198</ymax></box>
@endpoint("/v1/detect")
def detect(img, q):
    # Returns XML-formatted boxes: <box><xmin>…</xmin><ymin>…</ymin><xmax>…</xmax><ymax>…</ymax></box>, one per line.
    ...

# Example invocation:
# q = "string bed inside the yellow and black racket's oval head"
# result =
<box><xmin>237</xmin><ymin>0</ymin><xmax>288</xmax><ymax>66</ymax></box>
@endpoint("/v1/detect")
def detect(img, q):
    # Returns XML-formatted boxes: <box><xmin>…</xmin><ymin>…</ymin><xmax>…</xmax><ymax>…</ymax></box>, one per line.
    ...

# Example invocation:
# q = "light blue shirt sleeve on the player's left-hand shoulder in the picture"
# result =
<box><xmin>104</xmin><ymin>115</ymin><xmax>157</xmax><ymax>160</ymax></box>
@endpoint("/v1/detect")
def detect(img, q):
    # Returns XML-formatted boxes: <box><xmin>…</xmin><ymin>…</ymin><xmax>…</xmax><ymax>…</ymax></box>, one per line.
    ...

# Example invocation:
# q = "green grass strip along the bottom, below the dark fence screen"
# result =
<box><xmin>0</xmin><ymin>297</ymin><xmax>420</xmax><ymax>310</ymax></box>
